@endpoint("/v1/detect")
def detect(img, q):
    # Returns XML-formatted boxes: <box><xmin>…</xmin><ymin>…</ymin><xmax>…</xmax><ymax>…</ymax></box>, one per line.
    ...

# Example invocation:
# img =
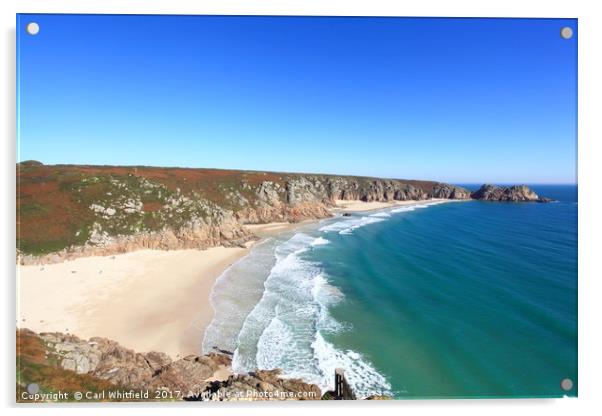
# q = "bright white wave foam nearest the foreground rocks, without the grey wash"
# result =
<box><xmin>232</xmin><ymin>232</ymin><xmax>390</xmax><ymax>397</ymax></box>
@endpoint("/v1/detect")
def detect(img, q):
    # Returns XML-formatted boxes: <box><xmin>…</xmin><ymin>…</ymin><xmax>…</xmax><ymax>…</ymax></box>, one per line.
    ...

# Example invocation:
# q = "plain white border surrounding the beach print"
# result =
<box><xmin>0</xmin><ymin>0</ymin><xmax>602</xmax><ymax>415</ymax></box>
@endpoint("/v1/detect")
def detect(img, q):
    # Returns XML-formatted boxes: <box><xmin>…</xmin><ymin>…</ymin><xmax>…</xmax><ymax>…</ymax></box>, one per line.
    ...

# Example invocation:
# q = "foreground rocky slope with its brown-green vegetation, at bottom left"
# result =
<box><xmin>17</xmin><ymin>329</ymin><xmax>321</xmax><ymax>401</ymax></box>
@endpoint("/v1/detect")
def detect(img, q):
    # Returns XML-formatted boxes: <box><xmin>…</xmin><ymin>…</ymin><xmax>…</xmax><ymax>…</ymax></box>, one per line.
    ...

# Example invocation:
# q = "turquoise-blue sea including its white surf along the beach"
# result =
<box><xmin>203</xmin><ymin>185</ymin><xmax>578</xmax><ymax>399</ymax></box>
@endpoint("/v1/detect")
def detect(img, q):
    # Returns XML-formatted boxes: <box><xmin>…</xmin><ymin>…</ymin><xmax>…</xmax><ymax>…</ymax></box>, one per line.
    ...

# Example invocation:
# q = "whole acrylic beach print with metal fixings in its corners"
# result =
<box><xmin>16</xmin><ymin>14</ymin><xmax>578</xmax><ymax>403</ymax></box>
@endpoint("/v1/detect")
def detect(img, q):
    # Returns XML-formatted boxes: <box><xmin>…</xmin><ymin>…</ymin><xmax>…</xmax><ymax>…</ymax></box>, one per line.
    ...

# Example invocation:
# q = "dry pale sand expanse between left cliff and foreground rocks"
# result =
<box><xmin>17</xmin><ymin>247</ymin><xmax>249</xmax><ymax>358</ymax></box>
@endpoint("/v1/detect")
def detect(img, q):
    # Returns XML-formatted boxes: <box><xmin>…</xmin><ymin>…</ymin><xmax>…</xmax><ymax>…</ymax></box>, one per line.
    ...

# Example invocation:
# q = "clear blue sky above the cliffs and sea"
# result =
<box><xmin>17</xmin><ymin>15</ymin><xmax>577</xmax><ymax>183</ymax></box>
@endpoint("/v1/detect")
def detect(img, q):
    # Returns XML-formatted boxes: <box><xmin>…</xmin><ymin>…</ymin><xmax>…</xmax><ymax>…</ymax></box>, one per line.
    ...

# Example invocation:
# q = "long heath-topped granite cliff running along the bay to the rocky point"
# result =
<box><xmin>17</xmin><ymin>161</ymin><xmax>549</xmax><ymax>264</ymax></box>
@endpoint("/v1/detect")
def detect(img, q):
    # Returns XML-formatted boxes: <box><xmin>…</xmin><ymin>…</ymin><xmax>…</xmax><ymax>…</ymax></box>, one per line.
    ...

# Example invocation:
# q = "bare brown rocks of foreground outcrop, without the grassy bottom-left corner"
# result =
<box><xmin>17</xmin><ymin>329</ymin><xmax>321</xmax><ymax>401</ymax></box>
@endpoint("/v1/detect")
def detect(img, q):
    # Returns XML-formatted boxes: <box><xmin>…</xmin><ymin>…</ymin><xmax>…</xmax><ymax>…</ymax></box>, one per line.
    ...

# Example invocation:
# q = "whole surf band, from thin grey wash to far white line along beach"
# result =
<box><xmin>203</xmin><ymin>204</ymin><xmax>446</xmax><ymax>397</ymax></box>
